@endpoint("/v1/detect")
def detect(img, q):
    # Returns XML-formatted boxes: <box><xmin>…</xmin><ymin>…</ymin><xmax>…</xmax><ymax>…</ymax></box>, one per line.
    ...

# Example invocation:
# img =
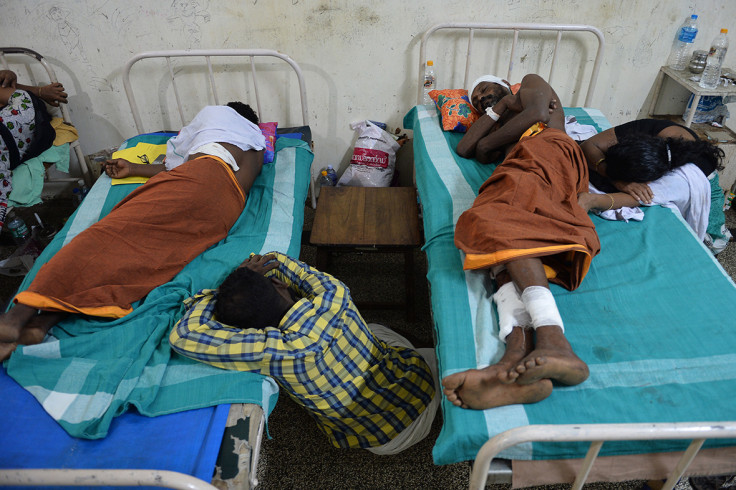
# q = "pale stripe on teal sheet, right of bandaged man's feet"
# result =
<box><xmin>568</xmin><ymin>354</ymin><xmax>736</xmax><ymax>391</ymax></box>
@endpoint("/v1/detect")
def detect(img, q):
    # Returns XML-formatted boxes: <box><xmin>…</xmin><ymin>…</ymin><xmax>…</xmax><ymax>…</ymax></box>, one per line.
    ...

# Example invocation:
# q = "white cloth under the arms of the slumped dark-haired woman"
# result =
<box><xmin>588</xmin><ymin>163</ymin><xmax>710</xmax><ymax>240</ymax></box>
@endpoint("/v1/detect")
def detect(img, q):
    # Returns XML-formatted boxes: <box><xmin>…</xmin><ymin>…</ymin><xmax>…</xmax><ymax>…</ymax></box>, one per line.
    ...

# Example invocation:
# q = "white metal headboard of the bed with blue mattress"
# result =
<box><xmin>123</xmin><ymin>49</ymin><xmax>317</xmax><ymax>209</ymax></box>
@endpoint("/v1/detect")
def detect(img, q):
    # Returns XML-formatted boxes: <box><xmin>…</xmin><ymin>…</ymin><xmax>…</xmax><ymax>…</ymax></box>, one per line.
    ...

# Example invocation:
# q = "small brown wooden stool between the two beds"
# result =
<box><xmin>310</xmin><ymin>187</ymin><xmax>422</xmax><ymax>321</ymax></box>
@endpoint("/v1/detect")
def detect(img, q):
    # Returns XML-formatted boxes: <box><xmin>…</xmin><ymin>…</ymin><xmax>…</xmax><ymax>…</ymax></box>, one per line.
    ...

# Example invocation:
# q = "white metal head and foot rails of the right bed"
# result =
<box><xmin>417</xmin><ymin>22</ymin><xmax>736</xmax><ymax>490</ymax></box>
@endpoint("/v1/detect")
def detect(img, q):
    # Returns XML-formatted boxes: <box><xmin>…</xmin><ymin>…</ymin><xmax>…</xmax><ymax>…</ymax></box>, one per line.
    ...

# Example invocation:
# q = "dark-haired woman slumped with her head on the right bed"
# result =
<box><xmin>580</xmin><ymin>119</ymin><xmax>730</xmax><ymax>253</ymax></box>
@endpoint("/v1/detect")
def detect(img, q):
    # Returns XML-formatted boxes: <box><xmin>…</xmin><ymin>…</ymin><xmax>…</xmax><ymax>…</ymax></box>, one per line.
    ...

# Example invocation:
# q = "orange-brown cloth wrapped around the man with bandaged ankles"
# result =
<box><xmin>455</xmin><ymin>128</ymin><xmax>600</xmax><ymax>290</ymax></box>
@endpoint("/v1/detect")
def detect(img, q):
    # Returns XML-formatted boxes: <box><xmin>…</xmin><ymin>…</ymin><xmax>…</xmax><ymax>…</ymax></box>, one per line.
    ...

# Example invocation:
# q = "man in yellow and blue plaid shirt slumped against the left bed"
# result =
<box><xmin>169</xmin><ymin>253</ymin><xmax>439</xmax><ymax>454</ymax></box>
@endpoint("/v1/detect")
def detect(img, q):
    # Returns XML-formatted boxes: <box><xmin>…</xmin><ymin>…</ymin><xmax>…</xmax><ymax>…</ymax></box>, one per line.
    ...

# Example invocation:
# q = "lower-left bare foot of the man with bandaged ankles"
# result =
<box><xmin>442</xmin><ymin>364</ymin><xmax>552</xmax><ymax>410</ymax></box>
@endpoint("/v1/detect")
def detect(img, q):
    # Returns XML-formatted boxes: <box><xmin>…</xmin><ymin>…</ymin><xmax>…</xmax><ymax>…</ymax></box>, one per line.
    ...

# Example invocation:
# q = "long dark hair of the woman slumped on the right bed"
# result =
<box><xmin>606</xmin><ymin>134</ymin><xmax>725</xmax><ymax>182</ymax></box>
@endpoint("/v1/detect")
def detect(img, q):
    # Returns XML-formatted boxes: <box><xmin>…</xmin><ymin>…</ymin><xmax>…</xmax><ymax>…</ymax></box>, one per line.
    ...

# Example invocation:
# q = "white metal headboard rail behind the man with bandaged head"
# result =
<box><xmin>417</xmin><ymin>22</ymin><xmax>605</xmax><ymax>107</ymax></box>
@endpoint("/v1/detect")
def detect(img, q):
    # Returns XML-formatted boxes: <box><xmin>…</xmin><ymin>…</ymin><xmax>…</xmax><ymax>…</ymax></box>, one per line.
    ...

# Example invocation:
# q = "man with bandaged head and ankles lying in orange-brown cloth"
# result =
<box><xmin>443</xmin><ymin>75</ymin><xmax>600</xmax><ymax>409</ymax></box>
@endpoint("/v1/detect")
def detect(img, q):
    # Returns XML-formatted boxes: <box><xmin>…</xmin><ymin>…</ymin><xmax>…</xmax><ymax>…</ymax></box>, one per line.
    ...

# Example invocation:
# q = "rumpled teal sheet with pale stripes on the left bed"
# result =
<box><xmin>5</xmin><ymin>138</ymin><xmax>313</xmax><ymax>439</ymax></box>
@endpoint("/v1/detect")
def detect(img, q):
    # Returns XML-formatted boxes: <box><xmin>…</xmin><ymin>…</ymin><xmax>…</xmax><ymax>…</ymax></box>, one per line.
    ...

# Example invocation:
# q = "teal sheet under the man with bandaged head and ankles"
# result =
<box><xmin>404</xmin><ymin>106</ymin><xmax>736</xmax><ymax>464</ymax></box>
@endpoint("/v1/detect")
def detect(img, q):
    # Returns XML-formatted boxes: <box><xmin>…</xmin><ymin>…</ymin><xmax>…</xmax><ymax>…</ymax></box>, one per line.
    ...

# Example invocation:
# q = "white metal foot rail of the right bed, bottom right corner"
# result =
<box><xmin>470</xmin><ymin>421</ymin><xmax>736</xmax><ymax>490</ymax></box>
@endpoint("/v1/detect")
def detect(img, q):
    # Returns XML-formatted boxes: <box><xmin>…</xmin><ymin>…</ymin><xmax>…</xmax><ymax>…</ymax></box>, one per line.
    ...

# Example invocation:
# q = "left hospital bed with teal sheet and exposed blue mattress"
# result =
<box><xmin>0</xmin><ymin>49</ymin><xmax>313</xmax><ymax>488</ymax></box>
